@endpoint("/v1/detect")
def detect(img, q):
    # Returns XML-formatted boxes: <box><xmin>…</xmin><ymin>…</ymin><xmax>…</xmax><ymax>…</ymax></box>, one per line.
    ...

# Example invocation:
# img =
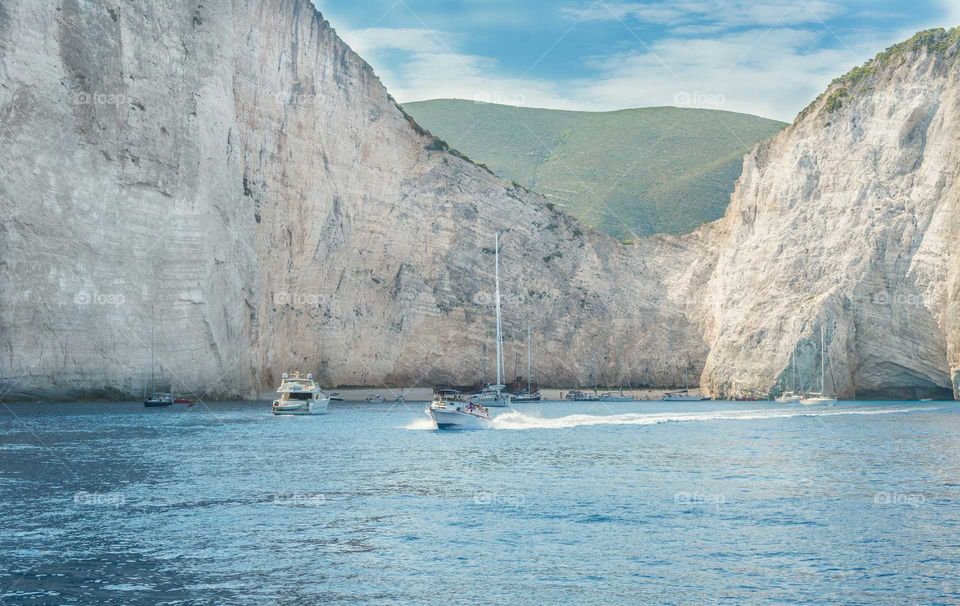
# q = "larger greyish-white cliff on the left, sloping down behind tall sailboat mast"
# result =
<box><xmin>0</xmin><ymin>0</ymin><xmax>706</xmax><ymax>397</ymax></box>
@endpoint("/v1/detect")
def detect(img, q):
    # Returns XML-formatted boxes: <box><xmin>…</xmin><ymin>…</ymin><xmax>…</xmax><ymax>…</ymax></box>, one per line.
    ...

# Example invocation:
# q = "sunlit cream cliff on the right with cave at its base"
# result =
<box><xmin>703</xmin><ymin>32</ymin><xmax>960</xmax><ymax>397</ymax></box>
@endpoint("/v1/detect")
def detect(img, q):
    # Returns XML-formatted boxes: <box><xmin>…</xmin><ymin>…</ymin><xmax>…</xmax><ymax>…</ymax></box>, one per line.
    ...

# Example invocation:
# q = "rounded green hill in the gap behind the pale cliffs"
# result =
<box><xmin>403</xmin><ymin>99</ymin><xmax>786</xmax><ymax>238</ymax></box>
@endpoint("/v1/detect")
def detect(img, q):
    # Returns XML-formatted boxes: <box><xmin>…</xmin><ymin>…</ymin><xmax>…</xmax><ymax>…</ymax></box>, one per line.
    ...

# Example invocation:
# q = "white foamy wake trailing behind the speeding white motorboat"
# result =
<box><xmin>493</xmin><ymin>407</ymin><xmax>939</xmax><ymax>429</ymax></box>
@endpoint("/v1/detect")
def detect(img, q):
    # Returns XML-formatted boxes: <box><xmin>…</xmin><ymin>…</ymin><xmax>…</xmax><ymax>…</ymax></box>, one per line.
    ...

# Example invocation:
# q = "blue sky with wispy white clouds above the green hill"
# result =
<box><xmin>314</xmin><ymin>0</ymin><xmax>960</xmax><ymax>121</ymax></box>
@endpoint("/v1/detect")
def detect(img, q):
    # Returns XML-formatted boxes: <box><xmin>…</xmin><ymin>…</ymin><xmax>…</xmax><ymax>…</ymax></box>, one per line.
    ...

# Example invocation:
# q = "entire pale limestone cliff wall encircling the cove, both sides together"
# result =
<box><xmin>0</xmin><ymin>0</ymin><xmax>960</xmax><ymax>398</ymax></box>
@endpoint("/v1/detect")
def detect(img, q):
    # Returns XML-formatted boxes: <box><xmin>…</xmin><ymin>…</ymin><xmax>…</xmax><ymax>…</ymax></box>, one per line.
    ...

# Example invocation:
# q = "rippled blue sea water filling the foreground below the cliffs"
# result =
<box><xmin>0</xmin><ymin>402</ymin><xmax>960</xmax><ymax>605</ymax></box>
